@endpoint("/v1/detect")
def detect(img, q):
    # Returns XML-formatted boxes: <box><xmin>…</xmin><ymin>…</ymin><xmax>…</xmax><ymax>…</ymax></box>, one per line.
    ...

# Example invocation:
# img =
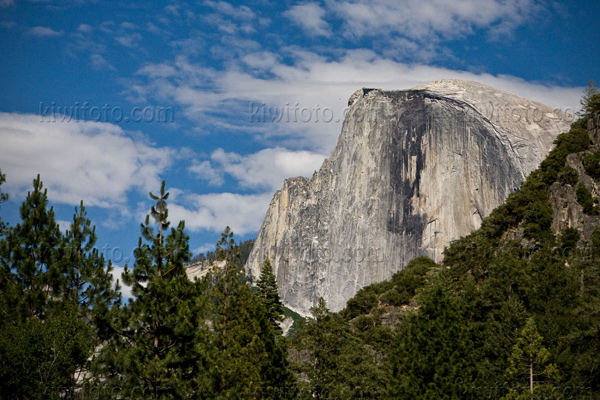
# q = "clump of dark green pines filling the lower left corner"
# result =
<box><xmin>0</xmin><ymin>175</ymin><xmax>120</xmax><ymax>398</ymax></box>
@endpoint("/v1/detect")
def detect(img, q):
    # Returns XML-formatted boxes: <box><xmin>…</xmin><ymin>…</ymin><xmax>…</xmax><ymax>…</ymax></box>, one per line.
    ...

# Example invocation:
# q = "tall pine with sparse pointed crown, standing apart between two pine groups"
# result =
<box><xmin>96</xmin><ymin>181</ymin><xmax>207</xmax><ymax>399</ymax></box>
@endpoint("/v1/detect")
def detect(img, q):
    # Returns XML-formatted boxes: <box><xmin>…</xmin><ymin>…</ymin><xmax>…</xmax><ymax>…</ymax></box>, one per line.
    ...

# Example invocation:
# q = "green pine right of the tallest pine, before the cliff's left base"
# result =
<box><xmin>208</xmin><ymin>227</ymin><xmax>294</xmax><ymax>399</ymax></box>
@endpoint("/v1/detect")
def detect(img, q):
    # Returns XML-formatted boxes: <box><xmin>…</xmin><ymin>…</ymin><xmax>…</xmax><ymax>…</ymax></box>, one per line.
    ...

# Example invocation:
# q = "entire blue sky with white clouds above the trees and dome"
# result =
<box><xmin>0</xmin><ymin>0</ymin><xmax>600</xmax><ymax>294</ymax></box>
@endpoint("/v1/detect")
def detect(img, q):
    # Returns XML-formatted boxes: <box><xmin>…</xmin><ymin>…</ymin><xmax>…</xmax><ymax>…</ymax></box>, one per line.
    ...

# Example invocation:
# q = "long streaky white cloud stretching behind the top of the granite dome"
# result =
<box><xmin>136</xmin><ymin>48</ymin><xmax>583</xmax><ymax>154</ymax></box>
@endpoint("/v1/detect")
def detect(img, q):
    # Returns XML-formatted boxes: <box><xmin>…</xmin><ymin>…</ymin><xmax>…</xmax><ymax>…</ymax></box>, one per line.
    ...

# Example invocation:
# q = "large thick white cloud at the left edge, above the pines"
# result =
<box><xmin>0</xmin><ymin>113</ymin><xmax>174</xmax><ymax>208</ymax></box>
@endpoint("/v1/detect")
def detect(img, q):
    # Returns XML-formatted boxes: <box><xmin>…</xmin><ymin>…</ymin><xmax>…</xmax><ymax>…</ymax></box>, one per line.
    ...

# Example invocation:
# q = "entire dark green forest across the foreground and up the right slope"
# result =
<box><xmin>0</xmin><ymin>86</ymin><xmax>600</xmax><ymax>400</ymax></box>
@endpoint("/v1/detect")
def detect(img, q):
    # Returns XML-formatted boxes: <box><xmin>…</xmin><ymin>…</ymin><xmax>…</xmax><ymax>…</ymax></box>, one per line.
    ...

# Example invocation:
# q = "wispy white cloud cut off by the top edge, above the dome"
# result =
<box><xmin>326</xmin><ymin>0</ymin><xmax>543</xmax><ymax>41</ymax></box>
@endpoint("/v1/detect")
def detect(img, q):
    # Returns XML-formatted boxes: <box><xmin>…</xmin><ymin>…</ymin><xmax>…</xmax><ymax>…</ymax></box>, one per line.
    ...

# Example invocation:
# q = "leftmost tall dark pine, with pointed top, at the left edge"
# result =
<box><xmin>0</xmin><ymin>175</ymin><xmax>92</xmax><ymax>398</ymax></box>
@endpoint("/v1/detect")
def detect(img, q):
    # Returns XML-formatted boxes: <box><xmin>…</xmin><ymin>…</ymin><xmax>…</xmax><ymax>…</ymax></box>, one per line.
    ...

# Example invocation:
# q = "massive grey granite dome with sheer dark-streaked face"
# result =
<box><xmin>246</xmin><ymin>80</ymin><xmax>570</xmax><ymax>315</ymax></box>
